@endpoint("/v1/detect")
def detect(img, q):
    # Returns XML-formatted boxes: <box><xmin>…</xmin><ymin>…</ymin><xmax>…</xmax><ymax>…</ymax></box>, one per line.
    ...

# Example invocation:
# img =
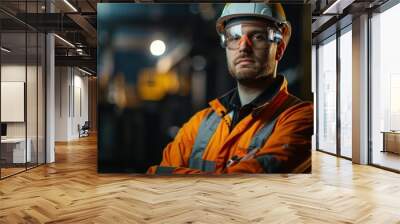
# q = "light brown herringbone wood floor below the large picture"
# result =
<box><xmin>0</xmin><ymin>134</ymin><xmax>400</xmax><ymax>224</ymax></box>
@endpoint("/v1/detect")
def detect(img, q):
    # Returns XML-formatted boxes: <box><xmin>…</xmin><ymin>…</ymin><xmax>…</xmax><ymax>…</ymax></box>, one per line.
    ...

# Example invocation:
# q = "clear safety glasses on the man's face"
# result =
<box><xmin>221</xmin><ymin>24</ymin><xmax>282</xmax><ymax>50</ymax></box>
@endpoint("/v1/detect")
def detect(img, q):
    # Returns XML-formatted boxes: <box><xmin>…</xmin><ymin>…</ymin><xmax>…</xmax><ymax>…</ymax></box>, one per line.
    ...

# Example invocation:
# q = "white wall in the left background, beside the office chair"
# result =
<box><xmin>55</xmin><ymin>67</ymin><xmax>89</xmax><ymax>141</ymax></box>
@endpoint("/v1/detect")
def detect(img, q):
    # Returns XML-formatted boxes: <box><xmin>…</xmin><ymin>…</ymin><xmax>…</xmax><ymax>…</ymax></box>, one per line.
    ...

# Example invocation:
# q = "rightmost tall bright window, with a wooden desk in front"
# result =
<box><xmin>370</xmin><ymin>1</ymin><xmax>400</xmax><ymax>170</ymax></box>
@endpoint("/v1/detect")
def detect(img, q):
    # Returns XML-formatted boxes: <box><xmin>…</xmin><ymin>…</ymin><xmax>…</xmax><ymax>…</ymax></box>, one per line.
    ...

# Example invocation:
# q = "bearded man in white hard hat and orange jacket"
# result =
<box><xmin>148</xmin><ymin>3</ymin><xmax>313</xmax><ymax>174</ymax></box>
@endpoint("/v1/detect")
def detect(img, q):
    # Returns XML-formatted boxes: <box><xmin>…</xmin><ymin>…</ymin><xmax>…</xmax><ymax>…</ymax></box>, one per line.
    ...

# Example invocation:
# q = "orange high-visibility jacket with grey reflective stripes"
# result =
<box><xmin>147</xmin><ymin>76</ymin><xmax>313</xmax><ymax>174</ymax></box>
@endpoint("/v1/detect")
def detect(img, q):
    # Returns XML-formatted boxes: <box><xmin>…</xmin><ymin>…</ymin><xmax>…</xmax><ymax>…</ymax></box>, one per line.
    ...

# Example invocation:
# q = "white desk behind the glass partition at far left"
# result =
<box><xmin>1</xmin><ymin>138</ymin><xmax>32</xmax><ymax>163</ymax></box>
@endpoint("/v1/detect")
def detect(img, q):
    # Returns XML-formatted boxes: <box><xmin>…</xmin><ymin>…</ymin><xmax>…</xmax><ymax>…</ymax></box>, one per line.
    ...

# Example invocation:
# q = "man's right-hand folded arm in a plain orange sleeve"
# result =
<box><xmin>226</xmin><ymin>104</ymin><xmax>313</xmax><ymax>173</ymax></box>
